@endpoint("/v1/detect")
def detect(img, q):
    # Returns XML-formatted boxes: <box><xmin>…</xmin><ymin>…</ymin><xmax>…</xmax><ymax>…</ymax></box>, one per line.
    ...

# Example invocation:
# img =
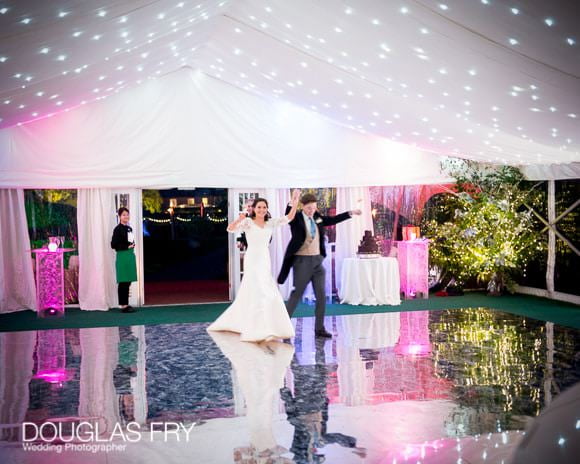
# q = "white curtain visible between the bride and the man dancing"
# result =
<box><xmin>266</xmin><ymin>189</ymin><xmax>292</xmax><ymax>300</ymax></box>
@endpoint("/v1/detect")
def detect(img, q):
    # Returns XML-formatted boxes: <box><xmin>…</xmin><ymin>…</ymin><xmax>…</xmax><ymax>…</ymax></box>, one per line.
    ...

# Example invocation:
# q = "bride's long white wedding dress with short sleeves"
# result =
<box><xmin>207</xmin><ymin>216</ymin><xmax>294</xmax><ymax>342</ymax></box>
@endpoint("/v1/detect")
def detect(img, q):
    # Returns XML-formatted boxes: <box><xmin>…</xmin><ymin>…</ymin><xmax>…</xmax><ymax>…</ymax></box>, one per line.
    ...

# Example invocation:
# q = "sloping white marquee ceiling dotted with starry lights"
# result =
<box><xmin>0</xmin><ymin>0</ymin><xmax>580</xmax><ymax>165</ymax></box>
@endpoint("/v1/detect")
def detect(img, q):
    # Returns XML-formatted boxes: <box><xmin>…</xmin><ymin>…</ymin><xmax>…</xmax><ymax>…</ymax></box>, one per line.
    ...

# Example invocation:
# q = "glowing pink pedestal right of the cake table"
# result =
<box><xmin>397</xmin><ymin>240</ymin><xmax>429</xmax><ymax>298</ymax></box>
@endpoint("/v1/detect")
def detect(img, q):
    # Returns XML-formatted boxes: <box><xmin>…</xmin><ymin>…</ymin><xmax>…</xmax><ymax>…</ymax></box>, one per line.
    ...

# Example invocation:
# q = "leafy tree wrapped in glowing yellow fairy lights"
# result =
<box><xmin>422</xmin><ymin>160</ymin><xmax>545</xmax><ymax>287</ymax></box>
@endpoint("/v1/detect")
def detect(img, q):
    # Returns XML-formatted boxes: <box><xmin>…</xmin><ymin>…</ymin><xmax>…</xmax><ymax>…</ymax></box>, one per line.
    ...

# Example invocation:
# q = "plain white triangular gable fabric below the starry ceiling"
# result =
<box><xmin>0</xmin><ymin>68</ymin><xmax>449</xmax><ymax>188</ymax></box>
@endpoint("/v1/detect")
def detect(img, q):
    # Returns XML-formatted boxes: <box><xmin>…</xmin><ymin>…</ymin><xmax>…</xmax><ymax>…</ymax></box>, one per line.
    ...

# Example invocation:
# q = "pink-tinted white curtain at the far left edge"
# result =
<box><xmin>0</xmin><ymin>189</ymin><xmax>36</xmax><ymax>313</ymax></box>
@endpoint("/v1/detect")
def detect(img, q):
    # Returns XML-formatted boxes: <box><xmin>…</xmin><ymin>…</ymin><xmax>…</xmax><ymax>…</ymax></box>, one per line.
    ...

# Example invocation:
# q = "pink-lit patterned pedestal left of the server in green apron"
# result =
<box><xmin>32</xmin><ymin>248</ymin><xmax>72</xmax><ymax>317</ymax></box>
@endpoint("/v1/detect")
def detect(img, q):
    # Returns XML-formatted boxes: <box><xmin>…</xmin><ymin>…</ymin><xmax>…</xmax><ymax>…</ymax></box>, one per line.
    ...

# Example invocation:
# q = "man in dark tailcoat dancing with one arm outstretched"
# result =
<box><xmin>278</xmin><ymin>193</ymin><xmax>361</xmax><ymax>338</ymax></box>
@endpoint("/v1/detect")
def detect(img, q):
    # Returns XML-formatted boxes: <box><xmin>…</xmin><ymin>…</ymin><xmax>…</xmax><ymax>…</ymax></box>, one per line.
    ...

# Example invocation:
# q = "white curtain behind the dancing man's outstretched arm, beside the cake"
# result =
<box><xmin>334</xmin><ymin>187</ymin><xmax>374</xmax><ymax>293</ymax></box>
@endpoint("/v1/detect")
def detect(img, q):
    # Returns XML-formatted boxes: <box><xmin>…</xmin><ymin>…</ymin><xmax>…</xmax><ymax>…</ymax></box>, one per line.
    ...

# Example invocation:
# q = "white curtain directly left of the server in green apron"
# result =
<box><xmin>77</xmin><ymin>189</ymin><xmax>117</xmax><ymax>311</ymax></box>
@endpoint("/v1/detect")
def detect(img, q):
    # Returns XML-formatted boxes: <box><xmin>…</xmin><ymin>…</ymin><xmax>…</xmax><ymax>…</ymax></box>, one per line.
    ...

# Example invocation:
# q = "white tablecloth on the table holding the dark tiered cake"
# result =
<box><xmin>339</xmin><ymin>258</ymin><xmax>401</xmax><ymax>306</ymax></box>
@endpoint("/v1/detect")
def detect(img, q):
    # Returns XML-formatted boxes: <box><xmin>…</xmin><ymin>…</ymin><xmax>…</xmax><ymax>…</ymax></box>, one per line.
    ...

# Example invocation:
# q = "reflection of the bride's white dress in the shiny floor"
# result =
<box><xmin>210</xmin><ymin>332</ymin><xmax>294</xmax><ymax>463</ymax></box>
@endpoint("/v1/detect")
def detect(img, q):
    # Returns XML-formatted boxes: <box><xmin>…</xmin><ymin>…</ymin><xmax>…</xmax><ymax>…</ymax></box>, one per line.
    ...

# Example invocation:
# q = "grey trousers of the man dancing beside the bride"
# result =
<box><xmin>286</xmin><ymin>255</ymin><xmax>326</xmax><ymax>331</ymax></box>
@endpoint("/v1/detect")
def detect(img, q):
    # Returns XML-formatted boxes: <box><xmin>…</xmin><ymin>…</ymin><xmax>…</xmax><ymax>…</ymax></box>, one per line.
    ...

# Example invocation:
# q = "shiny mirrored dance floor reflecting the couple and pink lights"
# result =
<box><xmin>0</xmin><ymin>308</ymin><xmax>580</xmax><ymax>464</ymax></box>
